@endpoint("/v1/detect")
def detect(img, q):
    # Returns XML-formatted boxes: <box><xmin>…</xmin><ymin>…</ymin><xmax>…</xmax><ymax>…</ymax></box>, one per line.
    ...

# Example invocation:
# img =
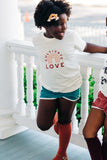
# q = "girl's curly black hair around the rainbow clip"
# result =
<box><xmin>34</xmin><ymin>0</ymin><xmax>71</xmax><ymax>29</ymax></box>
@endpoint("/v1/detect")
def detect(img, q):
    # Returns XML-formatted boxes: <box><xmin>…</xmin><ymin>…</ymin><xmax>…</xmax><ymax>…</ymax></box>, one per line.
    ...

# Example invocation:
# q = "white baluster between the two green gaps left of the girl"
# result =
<box><xmin>25</xmin><ymin>56</ymin><xmax>35</xmax><ymax>117</ymax></box>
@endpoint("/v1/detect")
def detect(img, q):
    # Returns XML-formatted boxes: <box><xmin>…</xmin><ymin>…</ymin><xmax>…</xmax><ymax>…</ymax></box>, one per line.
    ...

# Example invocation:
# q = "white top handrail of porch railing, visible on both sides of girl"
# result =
<box><xmin>6</xmin><ymin>40</ymin><xmax>107</xmax><ymax>66</ymax></box>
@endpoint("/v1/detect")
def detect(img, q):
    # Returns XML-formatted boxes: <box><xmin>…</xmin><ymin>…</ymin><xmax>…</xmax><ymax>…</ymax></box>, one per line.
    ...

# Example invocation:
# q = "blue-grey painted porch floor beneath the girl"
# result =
<box><xmin>0</xmin><ymin>129</ymin><xmax>90</xmax><ymax>160</ymax></box>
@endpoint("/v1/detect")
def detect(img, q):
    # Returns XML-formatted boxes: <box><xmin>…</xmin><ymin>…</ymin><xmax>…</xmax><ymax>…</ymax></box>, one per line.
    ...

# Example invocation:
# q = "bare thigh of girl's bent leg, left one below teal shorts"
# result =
<box><xmin>37</xmin><ymin>99</ymin><xmax>57</xmax><ymax>130</ymax></box>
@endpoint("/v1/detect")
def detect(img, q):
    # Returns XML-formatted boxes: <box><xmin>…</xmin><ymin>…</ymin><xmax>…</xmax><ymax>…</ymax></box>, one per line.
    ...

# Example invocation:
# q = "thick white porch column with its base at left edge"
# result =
<box><xmin>0</xmin><ymin>0</ymin><xmax>23</xmax><ymax>139</ymax></box>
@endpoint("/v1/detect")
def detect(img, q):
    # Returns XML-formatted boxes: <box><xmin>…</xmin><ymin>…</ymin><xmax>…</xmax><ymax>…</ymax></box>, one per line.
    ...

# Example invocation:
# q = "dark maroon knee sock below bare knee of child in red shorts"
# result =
<box><xmin>85</xmin><ymin>137</ymin><xmax>103</xmax><ymax>160</ymax></box>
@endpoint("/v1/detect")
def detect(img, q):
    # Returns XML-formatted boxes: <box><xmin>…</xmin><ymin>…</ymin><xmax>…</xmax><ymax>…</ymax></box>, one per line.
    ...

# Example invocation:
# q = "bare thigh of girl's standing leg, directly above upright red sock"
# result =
<box><xmin>58</xmin><ymin>98</ymin><xmax>77</xmax><ymax>124</ymax></box>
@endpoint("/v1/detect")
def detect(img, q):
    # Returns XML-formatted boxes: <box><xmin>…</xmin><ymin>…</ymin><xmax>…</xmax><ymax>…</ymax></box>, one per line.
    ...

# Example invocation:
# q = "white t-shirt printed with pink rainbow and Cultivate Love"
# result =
<box><xmin>33</xmin><ymin>30</ymin><xmax>86</xmax><ymax>93</ymax></box>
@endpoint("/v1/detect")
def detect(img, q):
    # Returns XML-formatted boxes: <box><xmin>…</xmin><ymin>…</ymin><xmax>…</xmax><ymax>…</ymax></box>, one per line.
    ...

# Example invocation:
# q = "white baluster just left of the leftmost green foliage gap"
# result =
<box><xmin>16</xmin><ymin>54</ymin><xmax>25</xmax><ymax>115</ymax></box>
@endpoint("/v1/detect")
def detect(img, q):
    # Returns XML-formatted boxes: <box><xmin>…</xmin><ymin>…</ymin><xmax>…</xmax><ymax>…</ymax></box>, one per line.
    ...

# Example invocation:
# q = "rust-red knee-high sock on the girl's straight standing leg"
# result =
<box><xmin>53</xmin><ymin>123</ymin><xmax>71</xmax><ymax>160</ymax></box>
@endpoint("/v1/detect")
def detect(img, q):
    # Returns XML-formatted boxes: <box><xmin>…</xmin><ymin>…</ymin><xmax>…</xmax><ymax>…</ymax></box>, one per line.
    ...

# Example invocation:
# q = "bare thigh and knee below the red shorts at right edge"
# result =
<box><xmin>83</xmin><ymin>108</ymin><xmax>105</xmax><ymax>138</ymax></box>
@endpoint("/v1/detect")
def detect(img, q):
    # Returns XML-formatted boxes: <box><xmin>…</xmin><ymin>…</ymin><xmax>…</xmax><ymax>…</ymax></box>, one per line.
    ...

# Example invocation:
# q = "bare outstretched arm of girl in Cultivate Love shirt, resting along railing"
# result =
<box><xmin>84</xmin><ymin>43</ymin><xmax>107</xmax><ymax>53</ymax></box>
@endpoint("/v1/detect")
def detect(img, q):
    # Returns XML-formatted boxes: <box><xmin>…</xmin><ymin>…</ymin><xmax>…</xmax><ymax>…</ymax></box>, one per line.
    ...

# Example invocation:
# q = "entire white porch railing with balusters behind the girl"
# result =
<box><xmin>7</xmin><ymin>41</ymin><xmax>107</xmax><ymax>147</ymax></box>
